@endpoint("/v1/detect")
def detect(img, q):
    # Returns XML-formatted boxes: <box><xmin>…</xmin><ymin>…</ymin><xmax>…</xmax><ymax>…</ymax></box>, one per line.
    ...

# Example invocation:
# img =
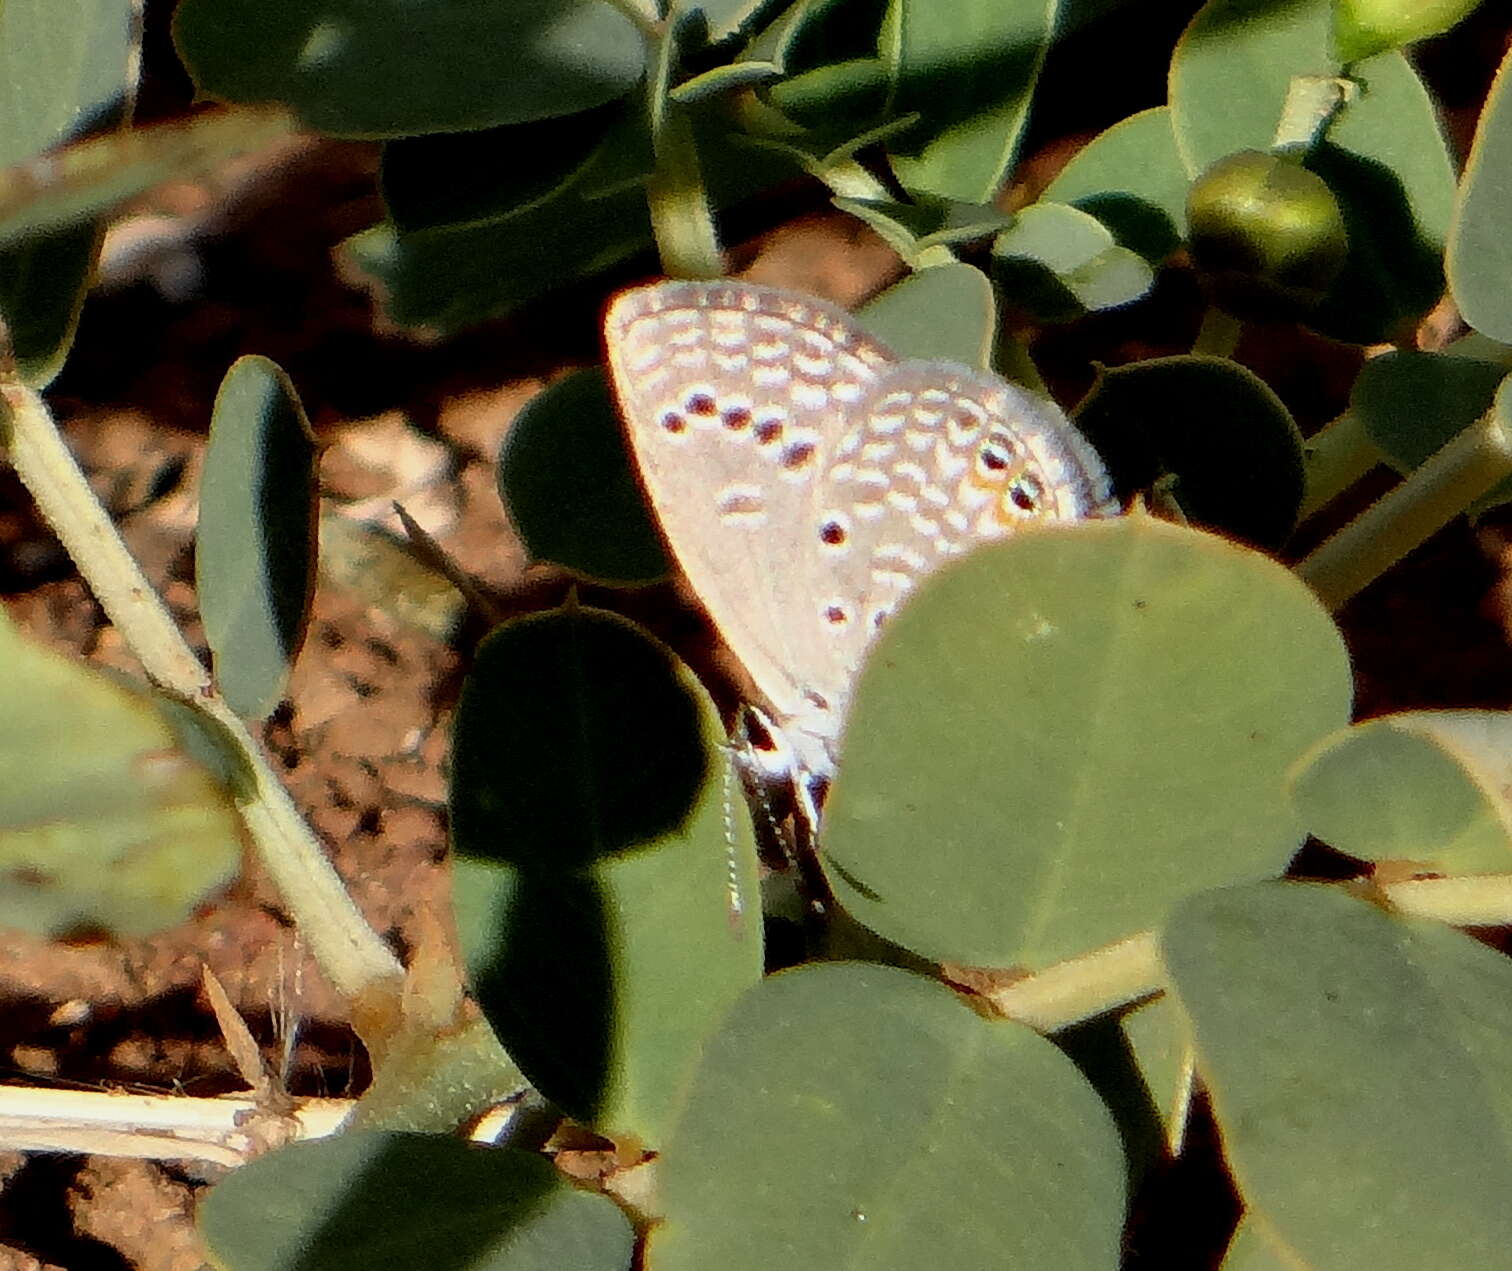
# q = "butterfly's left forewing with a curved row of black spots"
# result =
<box><xmin>605</xmin><ymin>283</ymin><xmax>894</xmax><ymax>734</ymax></box>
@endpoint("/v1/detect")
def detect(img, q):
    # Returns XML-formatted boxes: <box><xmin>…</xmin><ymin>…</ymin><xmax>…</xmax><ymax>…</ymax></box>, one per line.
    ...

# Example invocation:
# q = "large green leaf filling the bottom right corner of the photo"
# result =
<box><xmin>1161</xmin><ymin>883</ymin><xmax>1512</xmax><ymax>1271</ymax></box>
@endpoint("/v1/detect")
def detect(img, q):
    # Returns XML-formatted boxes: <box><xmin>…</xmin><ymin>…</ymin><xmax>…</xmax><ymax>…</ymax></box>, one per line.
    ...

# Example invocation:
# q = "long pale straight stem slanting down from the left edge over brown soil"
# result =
<box><xmin>0</xmin><ymin>379</ymin><xmax>404</xmax><ymax>1021</ymax></box>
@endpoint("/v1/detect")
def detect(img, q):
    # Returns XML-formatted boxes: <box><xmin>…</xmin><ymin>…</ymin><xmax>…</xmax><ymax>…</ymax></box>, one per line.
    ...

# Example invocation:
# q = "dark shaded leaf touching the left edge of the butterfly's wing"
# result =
<box><xmin>499</xmin><ymin>369</ymin><xmax>670</xmax><ymax>583</ymax></box>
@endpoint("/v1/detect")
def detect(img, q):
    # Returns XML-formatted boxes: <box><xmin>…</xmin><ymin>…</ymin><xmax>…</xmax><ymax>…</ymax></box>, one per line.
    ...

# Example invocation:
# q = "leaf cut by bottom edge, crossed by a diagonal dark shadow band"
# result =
<box><xmin>198</xmin><ymin>1132</ymin><xmax>635</xmax><ymax>1271</ymax></box>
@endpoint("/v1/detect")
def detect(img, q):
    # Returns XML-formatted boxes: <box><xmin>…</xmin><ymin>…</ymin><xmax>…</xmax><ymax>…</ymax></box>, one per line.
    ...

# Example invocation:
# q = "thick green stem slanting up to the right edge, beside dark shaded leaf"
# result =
<box><xmin>1297</xmin><ymin>411</ymin><xmax>1512</xmax><ymax>611</ymax></box>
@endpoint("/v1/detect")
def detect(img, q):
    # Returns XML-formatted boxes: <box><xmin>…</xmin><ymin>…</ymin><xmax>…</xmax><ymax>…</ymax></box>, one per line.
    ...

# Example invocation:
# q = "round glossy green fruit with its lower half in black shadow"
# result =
<box><xmin>1187</xmin><ymin>150</ymin><xmax>1349</xmax><ymax>319</ymax></box>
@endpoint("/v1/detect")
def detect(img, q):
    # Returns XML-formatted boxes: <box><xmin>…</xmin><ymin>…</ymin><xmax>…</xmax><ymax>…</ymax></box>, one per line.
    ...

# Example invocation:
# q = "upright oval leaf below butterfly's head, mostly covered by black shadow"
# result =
<box><xmin>451</xmin><ymin>609</ymin><xmax>762</xmax><ymax>1144</ymax></box>
